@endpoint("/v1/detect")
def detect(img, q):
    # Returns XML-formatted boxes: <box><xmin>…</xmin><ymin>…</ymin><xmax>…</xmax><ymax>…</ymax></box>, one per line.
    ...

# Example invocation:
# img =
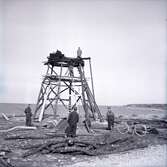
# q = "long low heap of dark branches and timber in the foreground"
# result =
<box><xmin>22</xmin><ymin>137</ymin><xmax>138</xmax><ymax>158</ymax></box>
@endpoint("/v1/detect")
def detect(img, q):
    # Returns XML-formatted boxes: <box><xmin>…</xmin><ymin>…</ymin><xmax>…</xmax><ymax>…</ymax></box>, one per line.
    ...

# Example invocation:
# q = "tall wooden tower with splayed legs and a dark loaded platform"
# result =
<box><xmin>33</xmin><ymin>48</ymin><xmax>103</xmax><ymax>122</ymax></box>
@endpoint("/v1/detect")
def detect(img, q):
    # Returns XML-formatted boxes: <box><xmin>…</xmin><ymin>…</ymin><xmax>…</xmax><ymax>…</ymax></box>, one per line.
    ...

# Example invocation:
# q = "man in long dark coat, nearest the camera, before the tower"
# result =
<box><xmin>65</xmin><ymin>107</ymin><xmax>79</xmax><ymax>137</ymax></box>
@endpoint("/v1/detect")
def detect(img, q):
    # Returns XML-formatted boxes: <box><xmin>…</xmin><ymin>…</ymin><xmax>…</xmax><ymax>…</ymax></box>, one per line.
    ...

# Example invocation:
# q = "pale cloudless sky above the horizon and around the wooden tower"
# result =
<box><xmin>0</xmin><ymin>0</ymin><xmax>167</xmax><ymax>105</ymax></box>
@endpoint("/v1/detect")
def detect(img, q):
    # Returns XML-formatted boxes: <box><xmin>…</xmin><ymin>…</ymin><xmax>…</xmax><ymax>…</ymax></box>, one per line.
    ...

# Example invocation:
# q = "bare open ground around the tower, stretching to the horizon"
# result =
<box><xmin>0</xmin><ymin>104</ymin><xmax>167</xmax><ymax>167</ymax></box>
